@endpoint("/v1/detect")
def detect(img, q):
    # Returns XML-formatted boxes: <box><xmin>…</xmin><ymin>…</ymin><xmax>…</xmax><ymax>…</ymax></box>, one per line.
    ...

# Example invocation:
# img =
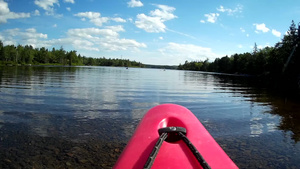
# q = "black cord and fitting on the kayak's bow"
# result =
<box><xmin>144</xmin><ymin>127</ymin><xmax>211</xmax><ymax>169</ymax></box>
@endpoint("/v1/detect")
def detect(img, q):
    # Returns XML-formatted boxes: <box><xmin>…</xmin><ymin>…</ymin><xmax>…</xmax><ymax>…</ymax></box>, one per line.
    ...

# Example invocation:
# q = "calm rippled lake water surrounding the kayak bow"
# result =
<box><xmin>0</xmin><ymin>67</ymin><xmax>300</xmax><ymax>168</ymax></box>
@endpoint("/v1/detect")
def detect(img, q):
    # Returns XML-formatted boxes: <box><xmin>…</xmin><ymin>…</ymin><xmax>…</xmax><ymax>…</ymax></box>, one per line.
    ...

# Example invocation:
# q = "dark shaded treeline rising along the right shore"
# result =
<box><xmin>178</xmin><ymin>21</ymin><xmax>300</xmax><ymax>87</ymax></box>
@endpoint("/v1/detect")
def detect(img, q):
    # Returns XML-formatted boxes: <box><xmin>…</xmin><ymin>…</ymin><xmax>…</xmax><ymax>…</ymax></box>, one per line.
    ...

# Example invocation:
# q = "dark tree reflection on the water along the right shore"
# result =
<box><xmin>216</xmin><ymin>75</ymin><xmax>300</xmax><ymax>143</ymax></box>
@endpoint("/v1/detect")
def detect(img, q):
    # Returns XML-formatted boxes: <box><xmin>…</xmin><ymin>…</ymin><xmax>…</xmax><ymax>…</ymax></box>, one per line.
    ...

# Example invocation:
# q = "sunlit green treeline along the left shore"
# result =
<box><xmin>0</xmin><ymin>40</ymin><xmax>144</xmax><ymax>67</ymax></box>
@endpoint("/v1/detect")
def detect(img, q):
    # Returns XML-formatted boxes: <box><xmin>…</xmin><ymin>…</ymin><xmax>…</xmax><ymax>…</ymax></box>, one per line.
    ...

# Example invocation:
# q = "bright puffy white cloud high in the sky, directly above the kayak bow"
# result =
<box><xmin>135</xmin><ymin>5</ymin><xmax>177</xmax><ymax>33</ymax></box>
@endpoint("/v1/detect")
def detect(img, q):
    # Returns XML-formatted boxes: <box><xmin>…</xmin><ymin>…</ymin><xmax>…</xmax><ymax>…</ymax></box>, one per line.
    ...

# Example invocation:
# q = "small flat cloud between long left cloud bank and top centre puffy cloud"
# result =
<box><xmin>74</xmin><ymin>12</ymin><xmax>126</xmax><ymax>27</ymax></box>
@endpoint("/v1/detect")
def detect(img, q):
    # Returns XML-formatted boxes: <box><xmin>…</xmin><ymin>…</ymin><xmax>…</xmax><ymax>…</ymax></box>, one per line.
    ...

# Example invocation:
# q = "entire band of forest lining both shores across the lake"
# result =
<box><xmin>0</xmin><ymin>21</ymin><xmax>300</xmax><ymax>89</ymax></box>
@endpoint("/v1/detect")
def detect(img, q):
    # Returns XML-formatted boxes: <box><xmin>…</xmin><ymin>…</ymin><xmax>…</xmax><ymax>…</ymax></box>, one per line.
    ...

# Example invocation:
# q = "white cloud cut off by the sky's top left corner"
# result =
<box><xmin>0</xmin><ymin>0</ymin><xmax>30</xmax><ymax>24</ymax></box>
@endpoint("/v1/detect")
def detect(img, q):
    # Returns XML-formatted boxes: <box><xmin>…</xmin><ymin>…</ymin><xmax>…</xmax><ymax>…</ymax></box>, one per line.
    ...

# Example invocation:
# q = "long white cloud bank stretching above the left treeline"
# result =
<box><xmin>0</xmin><ymin>25</ymin><xmax>147</xmax><ymax>51</ymax></box>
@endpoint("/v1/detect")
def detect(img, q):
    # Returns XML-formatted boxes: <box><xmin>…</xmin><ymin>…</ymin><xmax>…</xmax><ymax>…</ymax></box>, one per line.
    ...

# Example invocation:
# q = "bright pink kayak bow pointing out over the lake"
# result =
<box><xmin>113</xmin><ymin>104</ymin><xmax>238</xmax><ymax>169</ymax></box>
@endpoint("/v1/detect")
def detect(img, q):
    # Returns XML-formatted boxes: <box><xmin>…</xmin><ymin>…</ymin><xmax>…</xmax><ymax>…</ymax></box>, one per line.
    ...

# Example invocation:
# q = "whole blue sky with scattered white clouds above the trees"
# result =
<box><xmin>0</xmin><ymin>0</ymin><xmax>300</xmax><ymax>65</ymax></box>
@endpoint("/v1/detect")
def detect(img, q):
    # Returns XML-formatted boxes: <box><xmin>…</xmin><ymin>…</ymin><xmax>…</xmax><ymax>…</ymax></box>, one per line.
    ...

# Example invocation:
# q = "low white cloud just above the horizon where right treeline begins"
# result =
<box><xmin>159</xmin><ymin>42</ymin><xmax>219</xmax><ymax>64</ymax></box>
